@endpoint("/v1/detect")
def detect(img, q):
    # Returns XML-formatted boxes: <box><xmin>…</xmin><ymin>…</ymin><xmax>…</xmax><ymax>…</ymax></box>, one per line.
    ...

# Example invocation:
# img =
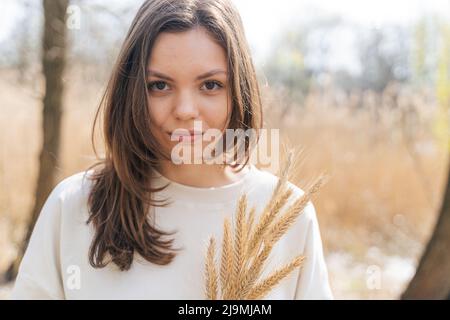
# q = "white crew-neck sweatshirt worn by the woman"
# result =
<box><xmin>11</xmin><ymin>165</ymin><xmax>333</xmax><ymax>300</ymax></box>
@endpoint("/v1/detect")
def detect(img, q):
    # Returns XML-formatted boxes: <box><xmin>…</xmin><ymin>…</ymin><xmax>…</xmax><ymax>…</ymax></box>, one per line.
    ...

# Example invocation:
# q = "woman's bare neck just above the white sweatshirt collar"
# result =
<box><xmin>158</xmin><ymin>161</ymin><xmax>249</xmax><ymax>188</ymax></box>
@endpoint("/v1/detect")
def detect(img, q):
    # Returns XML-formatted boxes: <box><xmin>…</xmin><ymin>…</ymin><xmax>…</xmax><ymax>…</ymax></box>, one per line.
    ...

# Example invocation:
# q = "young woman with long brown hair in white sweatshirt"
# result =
<box><xmin>12</xmin><ymin>0</ymin><xmax>332</xmax><ymax>299</ymax></box>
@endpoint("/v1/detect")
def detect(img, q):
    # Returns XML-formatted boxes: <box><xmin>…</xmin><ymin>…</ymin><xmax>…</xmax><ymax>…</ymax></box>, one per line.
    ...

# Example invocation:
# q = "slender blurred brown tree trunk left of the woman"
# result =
<box><xmin>5</xmin><ymin>0</ymin><xmax>69</xmax><ymax>281</ymax></box>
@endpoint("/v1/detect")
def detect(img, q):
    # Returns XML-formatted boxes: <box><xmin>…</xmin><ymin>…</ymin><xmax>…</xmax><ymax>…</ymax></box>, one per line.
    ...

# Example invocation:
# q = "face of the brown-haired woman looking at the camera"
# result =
<box><xmin>147</xmin><ymin>27</ymin><xmax>231</xmax><ymax>158</ymax></box>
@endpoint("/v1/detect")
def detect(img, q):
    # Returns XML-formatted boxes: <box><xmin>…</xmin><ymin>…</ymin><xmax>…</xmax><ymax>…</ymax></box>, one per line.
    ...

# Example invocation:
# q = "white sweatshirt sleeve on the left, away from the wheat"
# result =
<box><xmin>11</xmin><ymin>183</ymin><xmax>64</xmax><ymax>300</ymax></box>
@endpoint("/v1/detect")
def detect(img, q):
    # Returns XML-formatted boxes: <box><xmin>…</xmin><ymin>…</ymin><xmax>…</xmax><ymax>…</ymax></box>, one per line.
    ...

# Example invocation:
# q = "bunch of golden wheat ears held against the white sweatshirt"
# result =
<box><xmin>205</xmin><ymin>151</ymin><xmax>326</xmax><ymax>300</ymax></box>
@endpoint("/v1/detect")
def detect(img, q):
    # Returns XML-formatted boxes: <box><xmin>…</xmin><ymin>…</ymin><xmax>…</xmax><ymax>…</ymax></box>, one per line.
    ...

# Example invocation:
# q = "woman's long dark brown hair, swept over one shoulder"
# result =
<box><xmin>87</xmin><ymin>0</ymin><xmax>262</xmax><ymax>270</ymax></box>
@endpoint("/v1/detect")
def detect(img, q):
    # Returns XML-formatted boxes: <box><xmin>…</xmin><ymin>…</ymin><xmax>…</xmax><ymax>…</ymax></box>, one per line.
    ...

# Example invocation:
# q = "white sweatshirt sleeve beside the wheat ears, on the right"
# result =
<box><xmin>295</xmin><ymin>202</ymin><xmax>333</xmax><ymax>300</ymax></box>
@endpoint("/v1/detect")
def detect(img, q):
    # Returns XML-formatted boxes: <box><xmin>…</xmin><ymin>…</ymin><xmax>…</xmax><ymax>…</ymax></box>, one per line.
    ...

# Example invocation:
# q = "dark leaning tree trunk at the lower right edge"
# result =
<box><xmin>401</xmin><ymin>162</ymin><xmax>450</xmax><ymax>299</ymax></box>
